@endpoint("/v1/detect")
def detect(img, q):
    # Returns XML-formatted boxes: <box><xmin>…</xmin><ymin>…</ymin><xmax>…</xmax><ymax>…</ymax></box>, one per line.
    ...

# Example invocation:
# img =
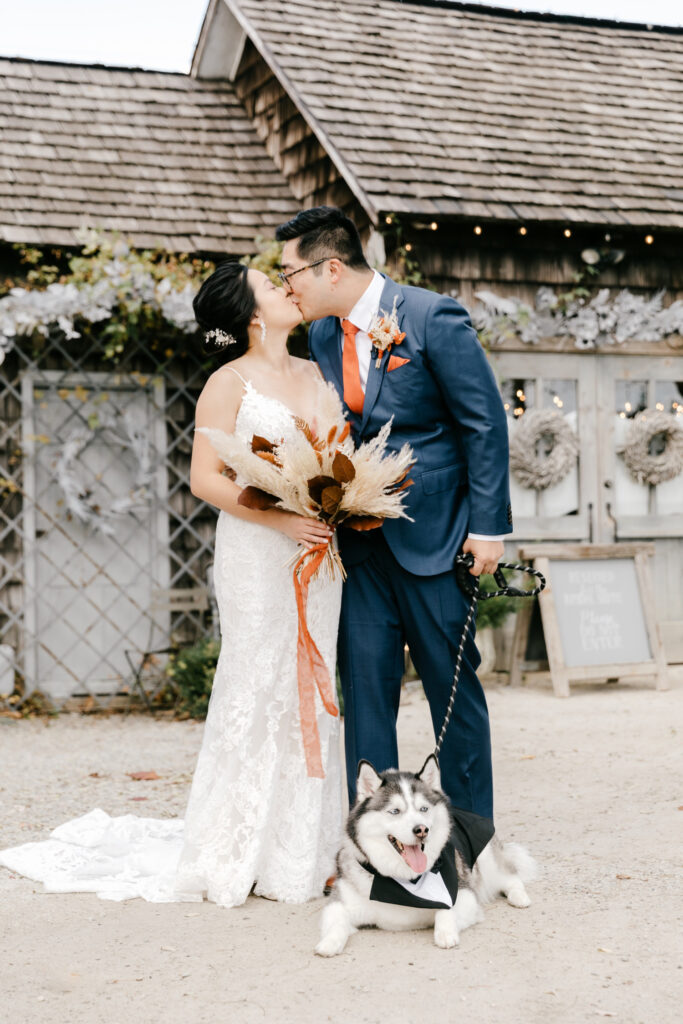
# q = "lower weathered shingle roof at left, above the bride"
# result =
<box><xmin>0</xmin><ymin>58</ymin><xmax>298</xmax><ymax>253</ymax></box>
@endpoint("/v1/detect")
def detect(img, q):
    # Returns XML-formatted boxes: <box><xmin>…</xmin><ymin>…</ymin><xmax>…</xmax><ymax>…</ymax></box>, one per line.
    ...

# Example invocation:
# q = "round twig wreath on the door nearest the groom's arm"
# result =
<box><xmin>510</xmin><ymin>409</ymin><xmax>579</xmax><ymax>490</ymax></box>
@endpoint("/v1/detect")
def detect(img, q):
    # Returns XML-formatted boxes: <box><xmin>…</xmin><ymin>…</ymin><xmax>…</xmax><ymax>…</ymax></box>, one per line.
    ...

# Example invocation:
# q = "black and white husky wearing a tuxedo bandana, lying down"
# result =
<box><xmin>315</xmin><ymin>754</ymin><xmax>536</xmax><ymax>956</ymax></box>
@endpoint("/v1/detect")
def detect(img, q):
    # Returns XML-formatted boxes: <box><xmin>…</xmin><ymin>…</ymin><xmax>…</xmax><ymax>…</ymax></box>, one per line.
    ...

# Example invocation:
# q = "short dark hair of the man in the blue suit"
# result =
<box><xmin>275</xmin><ymin>206</ymin><xmax>370</xmax><ymax>272</ymax></box>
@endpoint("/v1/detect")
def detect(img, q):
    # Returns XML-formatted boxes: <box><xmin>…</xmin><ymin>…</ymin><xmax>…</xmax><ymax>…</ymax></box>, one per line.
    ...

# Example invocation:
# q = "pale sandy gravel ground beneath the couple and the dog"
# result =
<box><xmin>0</xmin><ymin>676</ymin><xmax>683</xmax><ymax>1024</ymax></box>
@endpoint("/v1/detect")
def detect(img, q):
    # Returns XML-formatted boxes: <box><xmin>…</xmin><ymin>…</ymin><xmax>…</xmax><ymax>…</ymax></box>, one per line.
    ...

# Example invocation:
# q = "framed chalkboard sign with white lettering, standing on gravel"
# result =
<box><xmin>520</xmin><ymin>544</ymin><xmax>667</xmax><ymax>696</ymax></box>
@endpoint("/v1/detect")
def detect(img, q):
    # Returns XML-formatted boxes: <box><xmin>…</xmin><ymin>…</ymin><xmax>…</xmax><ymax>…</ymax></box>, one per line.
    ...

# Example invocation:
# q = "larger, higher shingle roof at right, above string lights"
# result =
<box><xmin>225</xmin><ymin>0</ymin><xmax>683</xmax><ymax>227</ymax></box>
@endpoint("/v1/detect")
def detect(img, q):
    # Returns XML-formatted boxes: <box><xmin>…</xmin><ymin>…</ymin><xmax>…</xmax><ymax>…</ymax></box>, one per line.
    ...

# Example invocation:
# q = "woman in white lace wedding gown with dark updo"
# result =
<box><xmin>0</xmin><ymin>262</ymin><xmax>342</xmax><ymax>906</ymax></box>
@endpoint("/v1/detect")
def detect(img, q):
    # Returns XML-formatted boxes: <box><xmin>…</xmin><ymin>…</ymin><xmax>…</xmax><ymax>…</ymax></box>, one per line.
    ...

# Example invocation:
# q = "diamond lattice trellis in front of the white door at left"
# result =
<box><xmin>0</xmin><ymin>332</ymin><xmax>215</xmax><ymax>708</ymax></box>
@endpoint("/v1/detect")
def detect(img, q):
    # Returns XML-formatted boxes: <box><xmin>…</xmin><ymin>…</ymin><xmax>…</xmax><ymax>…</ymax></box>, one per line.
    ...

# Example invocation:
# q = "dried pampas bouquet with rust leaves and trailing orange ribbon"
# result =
<box><xmin>198</xmin><ymin>384</ymin><xmax>415</xmax><ymax>778</ymax></box>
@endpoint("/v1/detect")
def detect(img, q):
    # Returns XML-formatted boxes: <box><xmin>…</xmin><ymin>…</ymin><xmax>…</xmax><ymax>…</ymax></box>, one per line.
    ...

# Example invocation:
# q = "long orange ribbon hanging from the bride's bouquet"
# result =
<box><xmin>294</xmin><ymin>544</ymin><xmax>339</xmax><ymax>778</ymax></box>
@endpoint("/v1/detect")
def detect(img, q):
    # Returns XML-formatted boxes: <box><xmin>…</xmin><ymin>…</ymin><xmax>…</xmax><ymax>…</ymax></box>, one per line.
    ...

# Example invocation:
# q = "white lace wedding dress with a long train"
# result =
<box><xmin>0</xmin><ymin>383</ymin><xmax>342</xmax><ymax>906</ymax></box>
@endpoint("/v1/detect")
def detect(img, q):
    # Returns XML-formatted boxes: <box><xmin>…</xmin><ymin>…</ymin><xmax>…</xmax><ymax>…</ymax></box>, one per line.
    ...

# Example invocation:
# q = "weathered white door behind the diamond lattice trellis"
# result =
<box><xmin>24</xmin><ymin>373</ymin><xmax>169</xmax><ymax>700</ymax></box>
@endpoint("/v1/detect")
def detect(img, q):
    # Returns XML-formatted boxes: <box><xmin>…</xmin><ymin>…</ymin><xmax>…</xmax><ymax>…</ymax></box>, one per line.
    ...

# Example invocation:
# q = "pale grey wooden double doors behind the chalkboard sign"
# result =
<box><xmin>492</xmin><ymin>351</ymin><xmax>683</xmax><ymax>662</ymax></box>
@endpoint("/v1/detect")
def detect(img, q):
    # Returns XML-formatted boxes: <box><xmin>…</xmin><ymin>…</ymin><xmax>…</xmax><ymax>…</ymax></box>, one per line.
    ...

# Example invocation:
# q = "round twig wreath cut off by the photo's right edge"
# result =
<box><xmin>617</xmin><ymin>409</ymin><xmax>683</xmax><ymax>486</ymax></box>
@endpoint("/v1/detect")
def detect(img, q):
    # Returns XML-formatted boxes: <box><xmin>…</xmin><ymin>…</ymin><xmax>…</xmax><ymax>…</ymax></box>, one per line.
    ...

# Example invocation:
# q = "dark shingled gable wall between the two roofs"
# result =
<box><xmin>229</xmin><ymin>40</ymin><xmax>368</xmax><ymax>229</ymax></box>
